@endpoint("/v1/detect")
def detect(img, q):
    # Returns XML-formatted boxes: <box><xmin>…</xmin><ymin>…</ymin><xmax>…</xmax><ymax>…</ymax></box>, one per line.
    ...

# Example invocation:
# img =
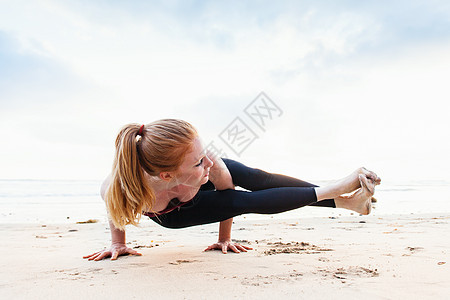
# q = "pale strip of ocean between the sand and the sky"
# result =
<box><xmin>0</xmin><ymin>180</ymin><xmax>450</xmax><ymax>224</ymax></box>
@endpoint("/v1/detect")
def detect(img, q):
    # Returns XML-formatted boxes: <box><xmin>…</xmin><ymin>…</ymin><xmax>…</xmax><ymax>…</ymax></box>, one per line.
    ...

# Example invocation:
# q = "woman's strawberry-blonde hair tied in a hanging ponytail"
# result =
<box><xmin>105</xmin><ymin>119</ymin><xmax>198</xmax><ymax>230</ymax></box>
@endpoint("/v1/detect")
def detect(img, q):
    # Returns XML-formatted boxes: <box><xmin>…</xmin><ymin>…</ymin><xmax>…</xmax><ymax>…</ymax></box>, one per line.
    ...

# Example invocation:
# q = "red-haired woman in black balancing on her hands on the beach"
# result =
<box><xmin>84</xmin><ymin>119</ymin><xmax>381</xmax><ymax>260</ymax></box>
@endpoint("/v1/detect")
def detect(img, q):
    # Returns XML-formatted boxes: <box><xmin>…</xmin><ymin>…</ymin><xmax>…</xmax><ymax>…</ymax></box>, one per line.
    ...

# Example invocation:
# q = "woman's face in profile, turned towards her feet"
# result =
<box><xmin>175</xmin><ymin>137</ymin><xmax>213</xmax><ymax>187</ymax></box>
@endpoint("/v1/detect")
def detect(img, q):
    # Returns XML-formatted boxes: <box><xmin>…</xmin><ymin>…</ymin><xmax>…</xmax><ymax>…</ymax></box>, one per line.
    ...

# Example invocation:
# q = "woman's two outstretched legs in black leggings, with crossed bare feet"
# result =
<box><xmin>151</xmin><ymin>160</ymin><xmax>374</xmax><ymax>228</ymax></box>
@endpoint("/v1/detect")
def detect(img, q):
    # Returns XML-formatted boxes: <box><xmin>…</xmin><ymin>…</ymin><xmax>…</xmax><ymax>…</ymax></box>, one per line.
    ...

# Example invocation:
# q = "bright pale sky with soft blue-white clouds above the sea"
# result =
<box><xmin>0</xmin><ymin>0</ymin><xmax>450</xmax><ymax>183</ymax></box>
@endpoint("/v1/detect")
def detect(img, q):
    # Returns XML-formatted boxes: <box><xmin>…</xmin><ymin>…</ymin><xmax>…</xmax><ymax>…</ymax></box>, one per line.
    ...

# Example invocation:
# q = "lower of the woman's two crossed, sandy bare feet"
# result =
<box><xmin>334</xmin><ymin>174</ymin><xmax>375</xmax><ymax>215</ymax></box>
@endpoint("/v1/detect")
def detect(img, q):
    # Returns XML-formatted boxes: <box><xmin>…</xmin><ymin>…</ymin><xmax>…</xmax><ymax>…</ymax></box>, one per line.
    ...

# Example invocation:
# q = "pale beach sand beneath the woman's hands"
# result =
<box><xmin>0</xmin><ymin>213</ymin><xmax>450</xmax><ymax>299</ymax></box>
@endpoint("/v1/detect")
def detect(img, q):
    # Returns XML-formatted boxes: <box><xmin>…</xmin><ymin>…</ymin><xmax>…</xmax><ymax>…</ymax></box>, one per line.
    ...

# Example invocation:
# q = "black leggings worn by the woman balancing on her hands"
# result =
<box><xmin>150</xmin><ymin>158</ymin><xmax>336</xmax><ymax>228</ymax></box>
